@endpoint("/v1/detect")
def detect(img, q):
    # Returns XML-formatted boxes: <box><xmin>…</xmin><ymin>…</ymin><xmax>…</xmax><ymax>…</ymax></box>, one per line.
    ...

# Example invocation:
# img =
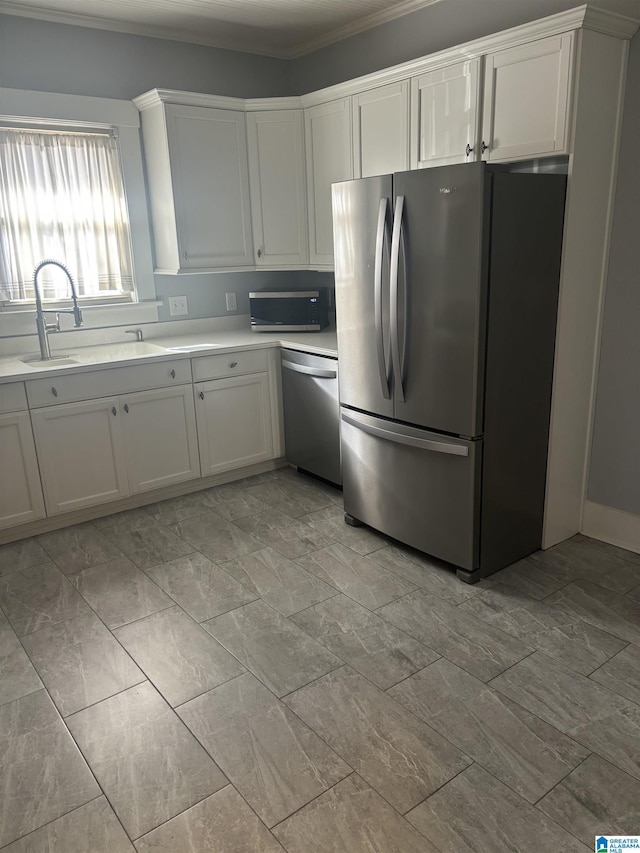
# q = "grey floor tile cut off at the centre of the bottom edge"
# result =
<box><xmin>274</xmin><ymin>773</ymin><xmax>437</xmax><ymax>853</ymax></box>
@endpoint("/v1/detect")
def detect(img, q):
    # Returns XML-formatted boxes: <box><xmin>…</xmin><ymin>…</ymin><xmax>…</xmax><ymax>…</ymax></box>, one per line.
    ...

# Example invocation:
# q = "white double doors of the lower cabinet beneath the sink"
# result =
<box><xmin>31</xmin><ymin>385</ymin><xmax>199</xmax><ymax>515</ymax></box>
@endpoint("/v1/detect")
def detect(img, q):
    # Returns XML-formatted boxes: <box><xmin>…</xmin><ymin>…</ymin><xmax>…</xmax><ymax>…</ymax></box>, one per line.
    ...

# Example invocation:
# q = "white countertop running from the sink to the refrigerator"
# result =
<box><xmin>0</xmin><ymin>325</ymin><xmax>338</xmax><ymax>383</ymax></box>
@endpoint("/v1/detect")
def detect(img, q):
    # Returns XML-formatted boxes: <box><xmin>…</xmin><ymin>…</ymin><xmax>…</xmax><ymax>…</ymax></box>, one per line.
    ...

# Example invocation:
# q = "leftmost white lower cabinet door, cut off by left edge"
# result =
<box><xmin>0</xmin><ymin>412</ymin><xmax>44</xmax><ymax>528</ymax></box>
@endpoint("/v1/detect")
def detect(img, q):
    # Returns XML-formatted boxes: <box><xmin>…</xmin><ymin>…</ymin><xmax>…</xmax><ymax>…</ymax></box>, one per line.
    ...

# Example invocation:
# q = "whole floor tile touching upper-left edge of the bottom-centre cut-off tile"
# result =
<box><xmin>178</xmin><ymin>673</ymin><xmax>351</xmax><ymax>826</ymax></box>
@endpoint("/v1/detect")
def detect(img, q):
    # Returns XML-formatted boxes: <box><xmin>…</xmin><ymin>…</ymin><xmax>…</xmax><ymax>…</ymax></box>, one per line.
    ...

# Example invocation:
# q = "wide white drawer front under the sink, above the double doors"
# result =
<box><xmin>25</xmin><ymin>358</ymin><xmax>191</xmax><ymax>408</ymax></box>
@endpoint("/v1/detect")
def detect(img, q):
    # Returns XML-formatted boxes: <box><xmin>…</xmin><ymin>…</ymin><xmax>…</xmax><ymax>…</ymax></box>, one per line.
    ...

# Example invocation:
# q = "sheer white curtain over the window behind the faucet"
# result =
<box><xmin>0</xmin><ymin>128</ymin><xmax>133</xmax><ymax>301</ymax></box>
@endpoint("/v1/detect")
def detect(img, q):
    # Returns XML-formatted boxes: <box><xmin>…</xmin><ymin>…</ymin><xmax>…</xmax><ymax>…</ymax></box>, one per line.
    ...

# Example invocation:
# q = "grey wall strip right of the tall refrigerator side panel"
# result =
<box><xmin>588</xmin><ymin>34</ymin><xmax>640</xmax><ymax>515</ymax></box>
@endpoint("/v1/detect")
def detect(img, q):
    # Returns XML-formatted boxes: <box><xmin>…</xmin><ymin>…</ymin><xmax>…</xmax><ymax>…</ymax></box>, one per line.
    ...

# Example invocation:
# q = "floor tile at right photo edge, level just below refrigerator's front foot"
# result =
<box><xmin>545</xmin><ymin>581</ymin><xmax>640</xmax><ymax>646</ymax></box>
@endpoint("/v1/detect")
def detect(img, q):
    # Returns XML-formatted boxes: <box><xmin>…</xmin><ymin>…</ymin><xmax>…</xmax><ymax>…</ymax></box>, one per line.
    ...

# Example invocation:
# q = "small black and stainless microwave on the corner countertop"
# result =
<box><xmin>249</xmin><ymin>287</ymin><xmax>329</xmax><ymax>332</ymax></box>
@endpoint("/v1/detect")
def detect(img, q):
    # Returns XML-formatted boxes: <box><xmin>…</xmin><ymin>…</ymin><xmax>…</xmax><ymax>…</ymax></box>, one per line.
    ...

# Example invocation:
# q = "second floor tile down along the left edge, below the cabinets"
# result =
<box><xmin>0</xmin><ymin>563</ymin><xmax>89</xmax><ymax>637</ymax></box>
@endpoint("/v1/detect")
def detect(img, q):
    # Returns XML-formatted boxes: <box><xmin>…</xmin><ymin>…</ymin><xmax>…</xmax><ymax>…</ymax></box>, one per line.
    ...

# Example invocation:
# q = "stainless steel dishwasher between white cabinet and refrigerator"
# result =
<box><xmin>280</xmin><ymin>349</ymin><xmax>342</xmax><ymax>485</ymax></box>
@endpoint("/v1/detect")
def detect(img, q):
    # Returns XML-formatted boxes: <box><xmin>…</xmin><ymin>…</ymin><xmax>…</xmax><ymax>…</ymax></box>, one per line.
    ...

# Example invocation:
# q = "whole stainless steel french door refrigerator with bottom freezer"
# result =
<box><xmin>332</xmin><ymin>162</ymin><xmax>566</xmax><ymax>583</ymax></box>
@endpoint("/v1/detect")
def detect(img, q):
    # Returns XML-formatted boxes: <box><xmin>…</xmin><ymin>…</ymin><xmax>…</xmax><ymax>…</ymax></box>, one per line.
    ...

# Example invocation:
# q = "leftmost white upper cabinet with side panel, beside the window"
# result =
<box><xmin>136</xmin><ymin>93</ymin><xmax>253</xmax><ymax>273</ymax></box>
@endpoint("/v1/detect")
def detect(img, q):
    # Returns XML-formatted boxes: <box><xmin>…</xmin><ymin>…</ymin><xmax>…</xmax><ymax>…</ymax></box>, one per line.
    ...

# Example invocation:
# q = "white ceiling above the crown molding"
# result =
<box><xmin>0</xmin><ymin>0</ymin><xmax>444</xmax><ymax>59</ymax></box>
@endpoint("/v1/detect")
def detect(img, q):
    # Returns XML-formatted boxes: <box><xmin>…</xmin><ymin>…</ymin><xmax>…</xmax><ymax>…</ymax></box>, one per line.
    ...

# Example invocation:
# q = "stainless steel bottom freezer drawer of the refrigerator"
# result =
<box><xmin>341</xmin><ymin>409</ymin><xmax>482</xmax><ymax>571</ymax></box>
